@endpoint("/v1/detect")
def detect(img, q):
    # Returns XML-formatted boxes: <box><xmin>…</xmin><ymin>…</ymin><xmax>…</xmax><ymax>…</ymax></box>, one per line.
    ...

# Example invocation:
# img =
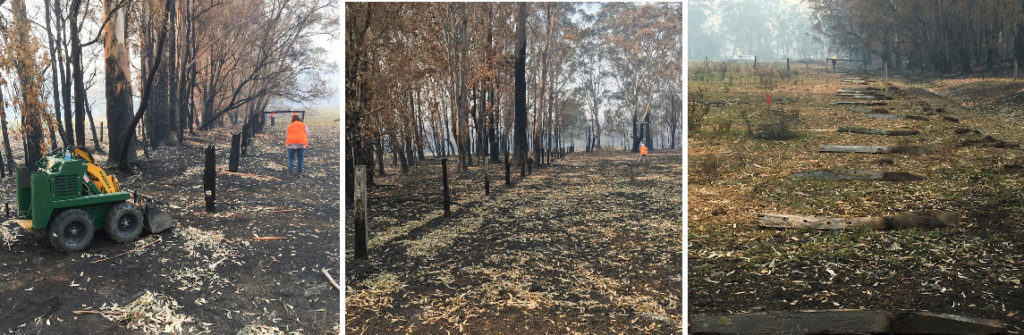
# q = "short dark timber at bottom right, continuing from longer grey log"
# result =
<box><xmin>892</xmin><ymin>311</ymin><xmax>1007</xmax><ymax>334</ymax></box>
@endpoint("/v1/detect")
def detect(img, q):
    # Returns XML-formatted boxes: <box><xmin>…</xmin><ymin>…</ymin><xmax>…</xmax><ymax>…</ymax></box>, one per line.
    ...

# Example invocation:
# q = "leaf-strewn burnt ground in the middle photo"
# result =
<box><xmin>345</xmin><ymin>151</ymin><xmax>682</xmax><ymax>334</ymax></box>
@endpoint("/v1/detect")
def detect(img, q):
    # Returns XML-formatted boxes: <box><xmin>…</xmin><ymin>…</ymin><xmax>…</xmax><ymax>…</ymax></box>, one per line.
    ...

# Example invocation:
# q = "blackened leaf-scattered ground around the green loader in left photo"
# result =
<box><xmin>0</xmin><ymin>112</ymin><xmax>340</xmax><ymax>334</ymax></box>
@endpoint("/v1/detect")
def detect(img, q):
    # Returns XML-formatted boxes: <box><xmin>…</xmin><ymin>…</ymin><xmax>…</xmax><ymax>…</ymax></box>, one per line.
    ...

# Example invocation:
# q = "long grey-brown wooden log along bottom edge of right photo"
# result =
<box><xmin>689</xmin><ymin>309</ymin><xmax>893</xmax><ymax>334</ymax></box>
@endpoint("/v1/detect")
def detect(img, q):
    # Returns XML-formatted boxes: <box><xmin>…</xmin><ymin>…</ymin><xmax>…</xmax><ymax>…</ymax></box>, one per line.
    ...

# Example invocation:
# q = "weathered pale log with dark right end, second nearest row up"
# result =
<box><xmin>758</xmin><ymin>210</ymin><xmax>959</xmax><ymax>231</ymax></box>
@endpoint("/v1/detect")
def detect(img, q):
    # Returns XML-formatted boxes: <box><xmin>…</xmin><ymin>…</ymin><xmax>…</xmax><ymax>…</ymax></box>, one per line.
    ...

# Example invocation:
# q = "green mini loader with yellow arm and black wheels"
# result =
<box><xmin>17</xmin><ymin>146</ymin><xmax>173</xmax><ymax>252</ymax></box>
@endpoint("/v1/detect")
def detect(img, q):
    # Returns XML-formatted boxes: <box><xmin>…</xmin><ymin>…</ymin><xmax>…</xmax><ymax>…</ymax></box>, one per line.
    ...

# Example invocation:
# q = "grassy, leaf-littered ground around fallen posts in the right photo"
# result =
<box><xmin>688</xmin><ymin>65</ymin><xmax>1024</xmax><ymax>332</ymax></box>
